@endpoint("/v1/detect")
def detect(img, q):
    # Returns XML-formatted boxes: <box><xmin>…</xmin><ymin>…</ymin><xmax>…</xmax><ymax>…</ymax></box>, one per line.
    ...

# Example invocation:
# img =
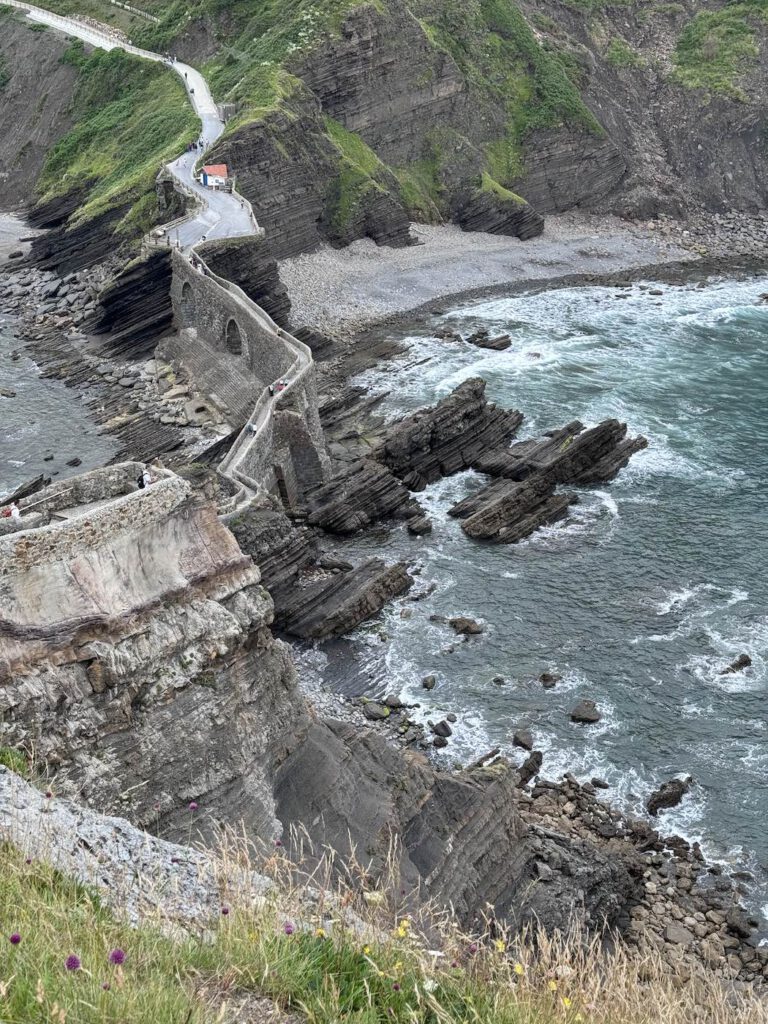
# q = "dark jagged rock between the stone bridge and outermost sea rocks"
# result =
<box><xmin>373</xmin><ymin>377</ymin><xmax>522</xmax><ymax>490</ymax></box>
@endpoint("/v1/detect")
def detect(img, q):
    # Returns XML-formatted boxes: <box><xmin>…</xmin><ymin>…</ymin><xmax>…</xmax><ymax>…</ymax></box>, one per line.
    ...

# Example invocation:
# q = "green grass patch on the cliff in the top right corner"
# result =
<box><xmin>673</xmin><ymin>0</ymin><xmax>768</xmax><ymax>100</ymax></box>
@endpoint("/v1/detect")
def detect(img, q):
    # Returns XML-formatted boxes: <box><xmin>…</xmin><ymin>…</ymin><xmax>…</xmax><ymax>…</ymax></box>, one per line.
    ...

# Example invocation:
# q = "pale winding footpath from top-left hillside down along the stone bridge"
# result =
<box><xmin>0</xmin><ymin>0</ymin><xmax>312</xmax><ymax>505</ymax></box>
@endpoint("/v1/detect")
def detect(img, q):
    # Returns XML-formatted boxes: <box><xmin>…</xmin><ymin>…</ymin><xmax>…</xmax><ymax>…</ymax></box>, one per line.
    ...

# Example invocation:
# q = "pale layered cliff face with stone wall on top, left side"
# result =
<box><xmin>0</xmin><ymin>467</ymin><xmax>307</xmax><ymax>837</ymax></box>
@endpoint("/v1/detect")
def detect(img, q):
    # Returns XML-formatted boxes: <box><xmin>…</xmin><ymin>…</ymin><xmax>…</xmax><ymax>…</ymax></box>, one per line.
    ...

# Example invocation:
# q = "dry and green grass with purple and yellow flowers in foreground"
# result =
<box><xmin>0</xmin><ymin>835</ymin><xmax>768</xmax><ymax>1024</ymax></box>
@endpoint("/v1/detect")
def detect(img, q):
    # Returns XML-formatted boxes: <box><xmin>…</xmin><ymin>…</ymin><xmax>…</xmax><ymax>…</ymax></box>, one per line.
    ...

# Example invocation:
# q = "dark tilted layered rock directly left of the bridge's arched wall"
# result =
<box><xmin>83</xmin><ymin>249</ymin><xmax>173</xmax><ymax>358</ymax></box>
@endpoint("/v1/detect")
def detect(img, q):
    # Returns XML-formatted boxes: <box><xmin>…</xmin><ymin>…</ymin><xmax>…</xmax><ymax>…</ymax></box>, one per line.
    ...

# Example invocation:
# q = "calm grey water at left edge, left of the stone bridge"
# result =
<box><xmin>0</xmin><ymin>314</ymin><xmax>116</xmax><ymax>497</ymax></box>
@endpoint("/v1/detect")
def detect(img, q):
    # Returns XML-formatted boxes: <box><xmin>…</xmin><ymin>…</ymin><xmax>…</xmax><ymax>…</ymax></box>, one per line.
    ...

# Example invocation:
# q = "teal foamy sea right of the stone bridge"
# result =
<box><xmin>314</xmin><ymin>279</ymin><xmax>768</xmax><ymax>925</ymax></box>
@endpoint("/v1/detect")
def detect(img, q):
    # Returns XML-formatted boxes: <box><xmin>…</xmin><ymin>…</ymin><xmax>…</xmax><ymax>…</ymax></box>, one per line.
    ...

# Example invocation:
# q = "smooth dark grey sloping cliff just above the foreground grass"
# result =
<box><xmin>275</xmin><ymin>721</ymin><xmax>636</xmax><ymax>927</ymax></box>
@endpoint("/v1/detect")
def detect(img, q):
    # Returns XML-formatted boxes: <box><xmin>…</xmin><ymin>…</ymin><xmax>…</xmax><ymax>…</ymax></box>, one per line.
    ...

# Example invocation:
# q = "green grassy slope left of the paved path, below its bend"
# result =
<box><xmin>37</xmin><ymin>42</ymin><xmax>200</xmax><ymax>237</ymax></box>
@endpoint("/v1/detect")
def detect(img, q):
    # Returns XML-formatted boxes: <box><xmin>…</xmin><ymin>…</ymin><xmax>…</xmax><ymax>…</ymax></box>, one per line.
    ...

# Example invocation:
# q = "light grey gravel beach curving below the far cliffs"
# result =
<box><xmin>280</xmin><ymin>214</ymin><xmax>695</xmax><ymax>338</ymax></box>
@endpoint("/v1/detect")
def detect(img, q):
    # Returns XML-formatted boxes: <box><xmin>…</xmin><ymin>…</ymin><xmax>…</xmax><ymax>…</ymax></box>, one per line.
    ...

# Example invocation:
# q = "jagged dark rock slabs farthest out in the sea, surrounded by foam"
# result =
<box><xmin>449</xmin><ymin>420</ymin><xmax>648</xmax><ymax>544</ymax></box>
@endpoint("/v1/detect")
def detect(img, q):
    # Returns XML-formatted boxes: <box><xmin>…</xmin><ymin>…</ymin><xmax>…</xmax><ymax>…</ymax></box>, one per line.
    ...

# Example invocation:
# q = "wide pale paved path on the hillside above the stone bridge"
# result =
<box><xmin>0</xmin><ymin>0</ymin><xmax>258</xmax><ymax>249</ymax></box>
